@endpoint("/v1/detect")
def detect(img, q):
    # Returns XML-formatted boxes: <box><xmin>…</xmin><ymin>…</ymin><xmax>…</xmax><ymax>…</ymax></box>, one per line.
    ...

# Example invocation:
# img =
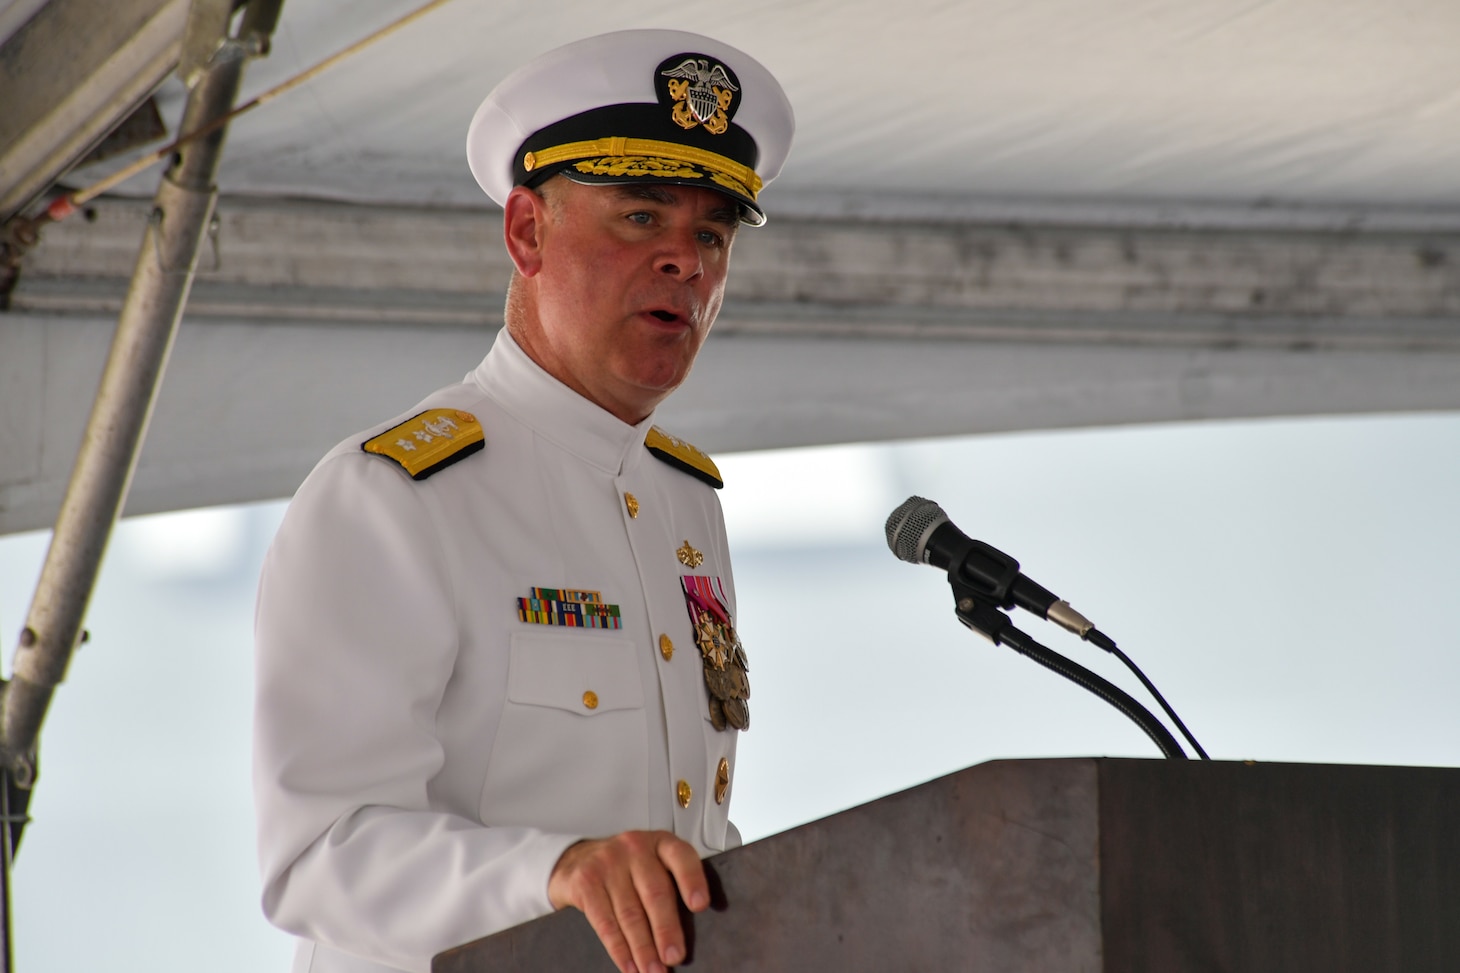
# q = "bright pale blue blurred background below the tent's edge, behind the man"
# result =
<box><xmin>0</xmin><ymin>415</ymin><xmax>1460</xmax><ymax>973</ymax></box>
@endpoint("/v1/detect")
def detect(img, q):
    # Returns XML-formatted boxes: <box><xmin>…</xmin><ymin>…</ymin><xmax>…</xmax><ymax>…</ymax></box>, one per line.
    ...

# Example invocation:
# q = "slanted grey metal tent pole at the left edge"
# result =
<box><xmin>0</xmin><ymin>0</ymin><xmax>282</xmax><ymax>972</ymax></box>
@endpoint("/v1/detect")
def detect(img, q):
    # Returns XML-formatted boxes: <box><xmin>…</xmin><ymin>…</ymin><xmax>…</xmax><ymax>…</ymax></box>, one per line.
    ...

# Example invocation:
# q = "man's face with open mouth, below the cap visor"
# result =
<box><xmin>507</xmin><ymin>178</ymin><xmax>739</xmax><ymax>424</ymax></box>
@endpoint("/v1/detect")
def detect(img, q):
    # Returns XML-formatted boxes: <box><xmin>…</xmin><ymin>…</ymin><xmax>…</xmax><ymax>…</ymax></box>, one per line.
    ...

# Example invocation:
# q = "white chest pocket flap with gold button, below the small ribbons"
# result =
<box><xmin>507</xmin><ymin>633</ymin><xmax>644</xmax><ymax>716</ymax></box>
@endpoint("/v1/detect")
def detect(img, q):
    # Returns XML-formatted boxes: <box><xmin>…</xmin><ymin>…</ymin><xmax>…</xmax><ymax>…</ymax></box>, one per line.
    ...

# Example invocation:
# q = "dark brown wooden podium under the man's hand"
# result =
<box><xmin>431</xmin><ymin>758</ymin><xmax>1460</xmax><ymax>973</ymax></box>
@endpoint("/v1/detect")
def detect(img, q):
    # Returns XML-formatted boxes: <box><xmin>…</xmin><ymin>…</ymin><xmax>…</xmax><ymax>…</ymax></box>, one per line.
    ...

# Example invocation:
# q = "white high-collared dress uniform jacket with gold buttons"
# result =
<box><xmin>254</xmin><ymin>329</ymin><xmax>739</xmax><ymax>973</ymax></box>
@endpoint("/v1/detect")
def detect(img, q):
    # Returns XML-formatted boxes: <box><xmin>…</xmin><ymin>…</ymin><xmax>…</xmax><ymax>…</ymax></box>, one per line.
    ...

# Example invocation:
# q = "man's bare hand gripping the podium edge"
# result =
<box><xmin>548</xmin><ymin>831</ymin><xmax>710</xmax><ymax>973</ymax></box>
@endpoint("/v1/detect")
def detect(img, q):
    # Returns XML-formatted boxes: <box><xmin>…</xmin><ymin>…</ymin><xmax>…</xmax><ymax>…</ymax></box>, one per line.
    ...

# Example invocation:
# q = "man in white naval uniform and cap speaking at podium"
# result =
<box><xmin>254</xmin><ymin>31</ymin><xmax>793</xmax><ymax>973</ymax></box>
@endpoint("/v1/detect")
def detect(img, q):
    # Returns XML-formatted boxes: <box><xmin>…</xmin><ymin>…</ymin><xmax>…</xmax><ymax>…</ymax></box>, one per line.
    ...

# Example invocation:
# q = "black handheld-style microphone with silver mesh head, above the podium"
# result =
<box><xmin>885</xmin><ymin>497</ymin><xmax>1098</xmax><ymax>638</ymax></box>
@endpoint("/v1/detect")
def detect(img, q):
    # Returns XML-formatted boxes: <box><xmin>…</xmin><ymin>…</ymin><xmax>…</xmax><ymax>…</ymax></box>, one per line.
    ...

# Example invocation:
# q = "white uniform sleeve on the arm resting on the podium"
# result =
<box><xmin>254</xmin><ymin>454</ymin><xmax>578</xmax><ymax>972</ymax></box>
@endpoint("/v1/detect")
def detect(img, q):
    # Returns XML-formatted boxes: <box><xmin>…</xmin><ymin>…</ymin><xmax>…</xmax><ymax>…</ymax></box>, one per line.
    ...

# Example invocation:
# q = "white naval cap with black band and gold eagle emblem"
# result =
<box><xmin>466</xmin><ymin>31</ymin><xmax>796</xmax><ymax>226</ymax></box>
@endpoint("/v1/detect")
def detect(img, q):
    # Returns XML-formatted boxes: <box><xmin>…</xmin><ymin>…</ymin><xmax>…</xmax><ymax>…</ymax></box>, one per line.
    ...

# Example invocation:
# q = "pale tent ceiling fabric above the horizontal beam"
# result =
<box><xmin>42</xmin><ymin>0</ymin><xmax>1460</xmax><ymax>211</ymax></box>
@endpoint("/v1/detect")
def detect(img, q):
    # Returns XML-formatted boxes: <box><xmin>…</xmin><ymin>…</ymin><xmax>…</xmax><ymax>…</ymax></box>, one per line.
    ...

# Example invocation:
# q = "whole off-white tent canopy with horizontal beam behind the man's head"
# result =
<box><xmin>0</xmin><ymin>0</ymin><xmax>1460</xmax><ymax>532</ymax></box>
